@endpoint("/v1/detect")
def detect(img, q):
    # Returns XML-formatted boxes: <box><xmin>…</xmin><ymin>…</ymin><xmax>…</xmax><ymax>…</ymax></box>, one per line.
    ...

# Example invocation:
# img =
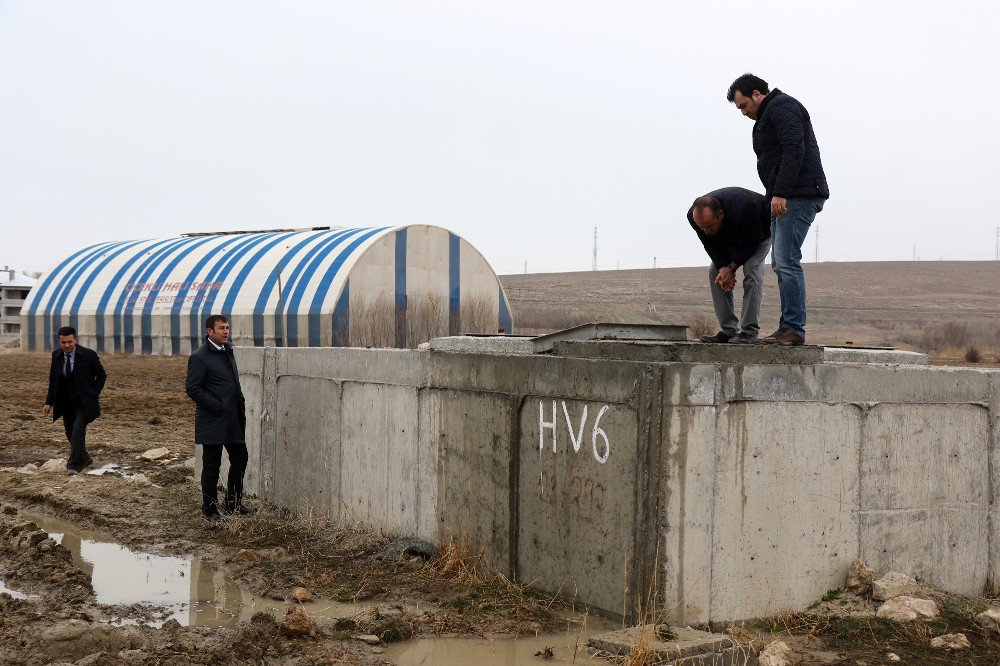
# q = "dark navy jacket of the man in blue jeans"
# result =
<box><xmin>753</xmin><ymin>88</ymin><xmax>830</xmax><ymax>199</ymax></box>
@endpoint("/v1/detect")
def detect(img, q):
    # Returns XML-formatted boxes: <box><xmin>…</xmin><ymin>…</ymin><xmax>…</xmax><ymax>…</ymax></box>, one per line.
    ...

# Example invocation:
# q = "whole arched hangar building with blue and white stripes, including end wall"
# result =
<box><xmin>21</xmin><ymin>225</ymin><xmax>513</xmax><ymax>355</ymax></box>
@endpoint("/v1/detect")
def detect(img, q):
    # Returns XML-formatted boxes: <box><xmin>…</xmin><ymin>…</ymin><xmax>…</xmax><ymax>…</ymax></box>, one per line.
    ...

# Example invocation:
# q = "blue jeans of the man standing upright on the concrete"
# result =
<box><xmin>771</xmin><ymin>199</ymin><xmax>825</xmax><ymax>337</ymax></box>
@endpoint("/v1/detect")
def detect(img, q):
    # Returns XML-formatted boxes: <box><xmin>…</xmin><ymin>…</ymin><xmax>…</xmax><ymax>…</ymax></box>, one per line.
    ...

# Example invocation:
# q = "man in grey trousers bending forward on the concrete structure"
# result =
<box><xmin>688</xmin><ymin>187</ymin><xmax>771</xmax><ymax>342</ymax></box>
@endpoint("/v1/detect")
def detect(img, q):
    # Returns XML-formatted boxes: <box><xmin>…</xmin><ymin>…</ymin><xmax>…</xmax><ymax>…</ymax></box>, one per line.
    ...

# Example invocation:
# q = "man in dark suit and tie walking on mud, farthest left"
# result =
<box><xmin>42</xmin><ymin>326</ymin><xmax>108</xmax><ymax>474</ymax></box>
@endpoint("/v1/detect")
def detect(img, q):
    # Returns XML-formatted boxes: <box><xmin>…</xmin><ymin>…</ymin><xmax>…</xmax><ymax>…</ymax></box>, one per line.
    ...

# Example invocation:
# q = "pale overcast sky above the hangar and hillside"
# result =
<box><xmin>0</xmin><ymin>0</ymin><xmax>1000</xmax><ymax>273</ymax></box>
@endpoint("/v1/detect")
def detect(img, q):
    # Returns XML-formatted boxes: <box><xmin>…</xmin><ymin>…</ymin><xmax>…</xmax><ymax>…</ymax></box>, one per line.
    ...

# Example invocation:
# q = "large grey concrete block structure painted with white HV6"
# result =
<box><xmin>230</xmin><ymin>341</ymin><xmax>1000</xmax><ymax>626</ymax></box>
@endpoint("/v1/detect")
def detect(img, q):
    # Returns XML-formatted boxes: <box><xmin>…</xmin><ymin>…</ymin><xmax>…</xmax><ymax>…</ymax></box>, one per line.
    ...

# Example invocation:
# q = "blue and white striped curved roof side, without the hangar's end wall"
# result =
<box><xmin>22</xmin><ymin>227</ymin><xmax>394</xmax><ymax>346</ymax></box>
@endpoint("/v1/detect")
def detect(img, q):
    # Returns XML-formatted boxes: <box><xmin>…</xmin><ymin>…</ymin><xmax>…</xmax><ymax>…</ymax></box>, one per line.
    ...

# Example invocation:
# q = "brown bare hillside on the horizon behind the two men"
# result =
<box><xmin>500</xmin><ymin>261</ymin><xmax>1000</xmax><ymax>348</ymax></box>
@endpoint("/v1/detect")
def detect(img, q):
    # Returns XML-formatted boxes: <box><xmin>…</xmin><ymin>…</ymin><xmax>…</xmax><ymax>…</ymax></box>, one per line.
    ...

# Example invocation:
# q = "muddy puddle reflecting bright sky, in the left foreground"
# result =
<box><xmin>22</xmin><ymin>511</ymin><xmax>382</xmax><ymax>627</ymax></box>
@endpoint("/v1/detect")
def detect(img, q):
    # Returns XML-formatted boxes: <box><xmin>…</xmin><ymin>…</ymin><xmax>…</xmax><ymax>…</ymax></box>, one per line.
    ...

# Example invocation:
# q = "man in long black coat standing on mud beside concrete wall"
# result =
<box><xmin>184</xmin><ymin>315</ymin><xmax>255</xmax><ymax>522</ymax></box>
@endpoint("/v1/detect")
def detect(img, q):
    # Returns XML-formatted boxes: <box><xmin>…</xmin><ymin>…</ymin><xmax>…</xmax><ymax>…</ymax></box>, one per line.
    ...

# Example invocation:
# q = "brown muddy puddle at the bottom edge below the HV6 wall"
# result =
<box><xmin>385</xmin><ymin>617</ymin><xmax>621</xmax><ymax>666</ymax></box>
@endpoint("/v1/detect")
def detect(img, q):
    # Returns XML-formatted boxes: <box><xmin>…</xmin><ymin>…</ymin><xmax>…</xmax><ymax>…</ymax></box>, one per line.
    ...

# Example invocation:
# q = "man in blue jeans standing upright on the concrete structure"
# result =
<box><xmin>726</xmin><ymin>74</ymin><xmax>830</xmax><ymax>345</ymax></box>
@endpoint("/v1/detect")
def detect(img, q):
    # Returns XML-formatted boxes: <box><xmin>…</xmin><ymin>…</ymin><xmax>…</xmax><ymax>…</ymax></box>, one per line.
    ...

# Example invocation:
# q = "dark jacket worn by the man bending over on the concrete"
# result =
<box><xmin>688</xmin><ymin>187</ymin><xmax>771</xmax><ymax>268</ymax></box>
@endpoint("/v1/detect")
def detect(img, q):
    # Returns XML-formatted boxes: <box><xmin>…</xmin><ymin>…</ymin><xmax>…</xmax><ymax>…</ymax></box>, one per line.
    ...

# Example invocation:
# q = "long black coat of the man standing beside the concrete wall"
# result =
<box><xmin>184</xmin><ymin>338</ymin><xmax>246</xmax><ymax>444</ymax></box>
